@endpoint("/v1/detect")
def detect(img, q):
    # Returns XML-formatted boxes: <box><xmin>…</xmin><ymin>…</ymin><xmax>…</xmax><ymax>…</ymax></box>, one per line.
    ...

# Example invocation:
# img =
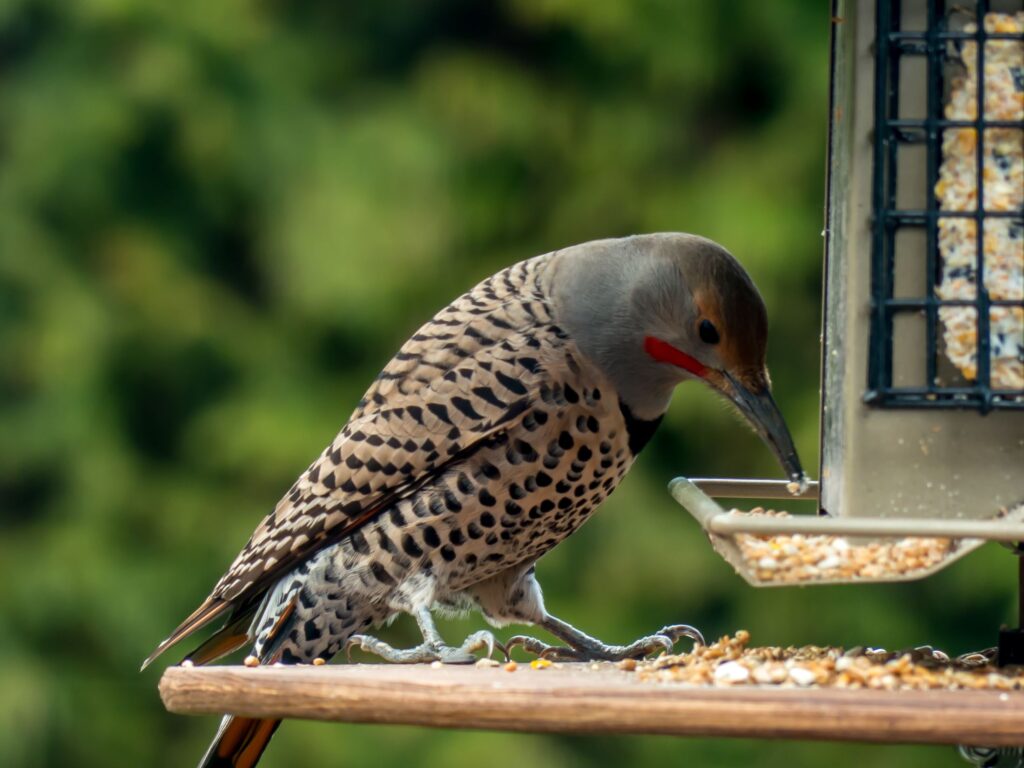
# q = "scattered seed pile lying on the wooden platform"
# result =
<box><xmin>633</xmin><ymin>630</ymin><xmax>1024</xmax><ymax>691</ymax></box>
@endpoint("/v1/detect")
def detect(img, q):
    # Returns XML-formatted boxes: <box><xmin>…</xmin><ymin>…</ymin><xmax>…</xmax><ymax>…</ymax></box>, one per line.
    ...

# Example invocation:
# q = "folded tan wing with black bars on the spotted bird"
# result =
<box><xmin>146</xmin><ymin>260</ymin><xmax>577</xmax><ymax>664</ymax></box>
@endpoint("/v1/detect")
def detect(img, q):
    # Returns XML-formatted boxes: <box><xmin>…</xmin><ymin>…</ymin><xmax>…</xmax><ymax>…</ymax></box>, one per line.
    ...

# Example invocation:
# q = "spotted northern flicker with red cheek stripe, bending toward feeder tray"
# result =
<box><xmin>145</xmin><ymin>233</ymin><xmax>804</xmax><ymax>766</ymax></box>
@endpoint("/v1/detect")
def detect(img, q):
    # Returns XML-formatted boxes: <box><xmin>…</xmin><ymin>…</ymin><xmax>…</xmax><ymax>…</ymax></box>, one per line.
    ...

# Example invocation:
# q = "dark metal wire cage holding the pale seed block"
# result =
<box><xmin>864</xmin><ymin>0</ymin><xmax>1024</xmax><ymax>413</ymax></box>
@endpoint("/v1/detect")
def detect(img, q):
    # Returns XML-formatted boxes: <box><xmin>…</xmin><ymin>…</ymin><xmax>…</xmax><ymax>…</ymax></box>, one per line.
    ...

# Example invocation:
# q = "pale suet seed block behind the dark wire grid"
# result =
<box><xmin>935</xmin><ymin>12</ymin><xmax>1024</xmax><ymax>389</ymax></box>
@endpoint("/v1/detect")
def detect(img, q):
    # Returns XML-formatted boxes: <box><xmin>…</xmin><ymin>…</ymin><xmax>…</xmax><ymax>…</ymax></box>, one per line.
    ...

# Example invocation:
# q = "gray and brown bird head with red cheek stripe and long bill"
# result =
<box><xmin>552</xmin><ymin>232</ymin><xmax>806</xmax><ymax>483</ymax></box>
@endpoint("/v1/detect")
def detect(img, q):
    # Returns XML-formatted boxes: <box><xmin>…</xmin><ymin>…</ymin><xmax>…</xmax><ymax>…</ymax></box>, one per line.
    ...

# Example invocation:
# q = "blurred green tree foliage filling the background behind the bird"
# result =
<box><xmin>0</xmin><ymin>0</ymin><xmax>1014</xmax><ymax>768</ymax></box>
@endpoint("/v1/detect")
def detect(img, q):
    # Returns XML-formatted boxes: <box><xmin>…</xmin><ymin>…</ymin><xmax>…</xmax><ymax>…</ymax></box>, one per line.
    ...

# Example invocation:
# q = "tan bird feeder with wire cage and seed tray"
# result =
<box><xmin>671</xmin><ymin>0</ymin><xmax>1024</xmax><ymax>651</ymax></box>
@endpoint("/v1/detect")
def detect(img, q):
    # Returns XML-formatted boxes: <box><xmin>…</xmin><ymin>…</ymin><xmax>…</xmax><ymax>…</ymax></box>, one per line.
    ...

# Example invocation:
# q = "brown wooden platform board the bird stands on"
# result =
<box><xmin>160</xmin><ymin>665</ymin><xmax>1024</xmax><ymax>746</ymax></box>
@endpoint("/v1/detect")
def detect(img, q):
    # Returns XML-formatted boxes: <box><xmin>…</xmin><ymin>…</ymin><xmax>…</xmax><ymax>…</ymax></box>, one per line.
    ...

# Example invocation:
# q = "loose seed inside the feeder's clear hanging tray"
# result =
<box><xmin>729</xmin><ymin>507</ymin><xmax>954</xmax><ymax>584</ymax></box>
